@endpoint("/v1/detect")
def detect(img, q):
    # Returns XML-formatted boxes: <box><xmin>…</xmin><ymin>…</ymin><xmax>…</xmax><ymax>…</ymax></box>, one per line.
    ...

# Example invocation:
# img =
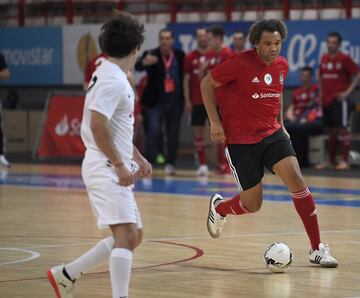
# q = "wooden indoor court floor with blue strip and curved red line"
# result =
<box><xmin>0</xmin><ymin>165</ymin><xmax>360</xmax><ymax>298</ymax></box>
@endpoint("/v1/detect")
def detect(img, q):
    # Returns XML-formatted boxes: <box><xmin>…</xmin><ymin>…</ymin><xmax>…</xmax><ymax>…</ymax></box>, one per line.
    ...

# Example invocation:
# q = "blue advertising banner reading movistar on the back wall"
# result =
<box><xmin>0</xmin><ymin>27</ymin><xmax>63</xmax><ymax>85</ymax></box>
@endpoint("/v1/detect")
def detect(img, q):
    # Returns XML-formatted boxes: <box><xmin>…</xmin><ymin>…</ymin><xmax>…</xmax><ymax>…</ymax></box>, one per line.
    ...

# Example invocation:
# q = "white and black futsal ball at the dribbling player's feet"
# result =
<box><xmin>264</xmin><ymin>242</ymin><xmax>294</xmax><ymax>273</ymax></box>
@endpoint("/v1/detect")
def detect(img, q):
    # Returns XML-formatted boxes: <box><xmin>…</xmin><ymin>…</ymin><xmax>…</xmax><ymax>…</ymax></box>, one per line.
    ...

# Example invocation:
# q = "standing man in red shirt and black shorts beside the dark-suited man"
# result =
<box><xmin>184</xmin><ymin>28</ymin><xmax>209</xmax><ymax>176</ymax></box>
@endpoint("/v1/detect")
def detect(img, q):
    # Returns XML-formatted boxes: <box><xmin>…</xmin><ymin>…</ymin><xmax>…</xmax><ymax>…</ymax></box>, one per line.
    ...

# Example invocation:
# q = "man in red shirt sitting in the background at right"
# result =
<box><xmin>285</xmin><ymin>66</ymin><xmax>323</xmax><ymax>167</ymax></box>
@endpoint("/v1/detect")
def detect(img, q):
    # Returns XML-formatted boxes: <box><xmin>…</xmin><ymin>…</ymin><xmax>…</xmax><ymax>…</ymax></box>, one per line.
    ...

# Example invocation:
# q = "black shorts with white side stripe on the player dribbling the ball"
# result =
<box><xmin>225</xmin><ymin>129</ymin><xmax>296</xmax><ymax>191</ymax></box>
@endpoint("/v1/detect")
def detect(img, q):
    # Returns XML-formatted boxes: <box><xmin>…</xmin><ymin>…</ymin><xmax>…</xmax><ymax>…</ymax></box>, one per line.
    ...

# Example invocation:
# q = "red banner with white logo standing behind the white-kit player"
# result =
<box><xmin>37</xmin><ymin>95</ymin><xmax>85</xmax><ymax>158</ymax></box>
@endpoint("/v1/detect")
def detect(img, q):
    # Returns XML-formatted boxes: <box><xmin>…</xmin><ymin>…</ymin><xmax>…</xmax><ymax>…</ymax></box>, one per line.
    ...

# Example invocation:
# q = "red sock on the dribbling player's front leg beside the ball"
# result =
<box><xmin>291</xmin><ymin>188</ymin><xmax>320</xmax><ymax>250</ymax></box>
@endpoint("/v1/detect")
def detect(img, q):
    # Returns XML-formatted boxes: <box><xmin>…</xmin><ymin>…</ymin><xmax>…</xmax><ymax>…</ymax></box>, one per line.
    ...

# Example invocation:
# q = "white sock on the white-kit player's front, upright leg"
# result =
<box><xmin>110</xmin><ymin>248</ymin><xmax>133</xmax><ymax>298</ymax></box>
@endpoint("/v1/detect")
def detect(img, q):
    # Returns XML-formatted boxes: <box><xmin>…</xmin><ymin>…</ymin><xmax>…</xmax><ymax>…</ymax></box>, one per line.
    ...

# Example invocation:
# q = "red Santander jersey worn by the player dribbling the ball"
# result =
<box><xmin>211</xmin><ymin>49</ymin><xmax>289</xmax><ymax>144</ymax></box>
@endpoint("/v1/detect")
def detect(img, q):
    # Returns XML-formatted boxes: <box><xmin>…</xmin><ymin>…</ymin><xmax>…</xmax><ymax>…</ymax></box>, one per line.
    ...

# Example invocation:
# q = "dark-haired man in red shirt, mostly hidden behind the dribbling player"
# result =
<box><xmin>199</xmin><ymin>26</ymin><xmax>233</xmax><ymax>174</ymax></box>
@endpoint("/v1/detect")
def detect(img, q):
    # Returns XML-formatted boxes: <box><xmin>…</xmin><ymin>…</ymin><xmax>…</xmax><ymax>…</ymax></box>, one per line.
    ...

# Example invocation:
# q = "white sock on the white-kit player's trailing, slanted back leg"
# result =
<box><xmin>65</xmin><ymin>236</ymin><xmax>114</xmax><ymax>279</ymax></box>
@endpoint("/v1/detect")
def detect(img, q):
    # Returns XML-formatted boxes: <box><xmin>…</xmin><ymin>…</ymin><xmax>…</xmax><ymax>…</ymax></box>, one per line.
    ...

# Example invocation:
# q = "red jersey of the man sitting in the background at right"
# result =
<box><xmin>292</xmin><ymin>84</ymin><xmax>320</xmax><ymax>119</ymax></box>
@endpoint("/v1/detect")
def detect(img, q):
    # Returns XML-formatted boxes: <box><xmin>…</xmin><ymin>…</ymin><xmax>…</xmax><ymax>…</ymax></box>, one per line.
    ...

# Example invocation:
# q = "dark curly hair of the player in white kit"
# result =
<box><xmin>100</xmin><ymin>13</ymin><xmax>145</xmax><ymax>58</ymax></box>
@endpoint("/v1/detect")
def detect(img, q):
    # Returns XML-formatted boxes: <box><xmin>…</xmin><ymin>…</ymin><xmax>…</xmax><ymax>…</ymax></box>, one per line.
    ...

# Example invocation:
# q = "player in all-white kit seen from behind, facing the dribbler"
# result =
<box><xmin>47</xmin><ymin>14</ymin><xmax>152</xmax><ymax>298</ymax></box>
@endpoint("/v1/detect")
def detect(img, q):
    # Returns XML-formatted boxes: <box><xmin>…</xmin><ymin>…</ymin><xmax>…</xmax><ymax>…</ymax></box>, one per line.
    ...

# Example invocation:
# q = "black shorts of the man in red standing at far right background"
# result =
<box><xmin>324</xmin><ymin>100</ymin><xmax>350</xmax><ymax>128</ymax></box>
